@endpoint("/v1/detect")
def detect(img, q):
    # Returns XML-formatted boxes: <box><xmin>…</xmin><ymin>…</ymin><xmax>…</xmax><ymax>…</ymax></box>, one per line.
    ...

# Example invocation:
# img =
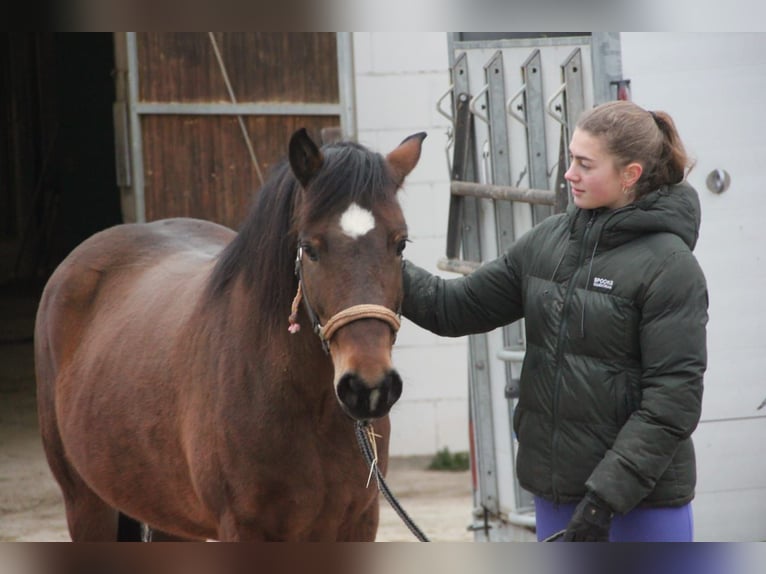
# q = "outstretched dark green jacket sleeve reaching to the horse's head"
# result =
<box><xmin>402</xmin><ymin>243</ymin><xmax>523</xmax><ymax>337</ymax></box>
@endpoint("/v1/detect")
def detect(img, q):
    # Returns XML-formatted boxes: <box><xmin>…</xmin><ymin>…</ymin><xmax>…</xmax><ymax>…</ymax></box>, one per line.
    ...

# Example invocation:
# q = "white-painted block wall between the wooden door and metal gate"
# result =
<box><xmin>353</xmin><ymin>32</ymin><xmax>468</xmax><ymax>455</ymax></box>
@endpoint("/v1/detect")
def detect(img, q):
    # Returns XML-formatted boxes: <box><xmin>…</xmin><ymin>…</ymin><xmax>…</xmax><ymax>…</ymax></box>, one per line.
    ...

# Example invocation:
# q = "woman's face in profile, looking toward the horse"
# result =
<box><xmin>564</xmin><ymin>129</ymin><xmax>635</xmax><ymax>209</ymax></box>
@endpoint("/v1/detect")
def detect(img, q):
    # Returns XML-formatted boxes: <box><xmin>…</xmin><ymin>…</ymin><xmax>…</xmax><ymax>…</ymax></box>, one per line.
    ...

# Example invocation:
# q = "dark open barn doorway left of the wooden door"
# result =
<box><xmin>0</xmin><ymin>32</ymin><xmax>121</xmax><ymax>291</ymax></box>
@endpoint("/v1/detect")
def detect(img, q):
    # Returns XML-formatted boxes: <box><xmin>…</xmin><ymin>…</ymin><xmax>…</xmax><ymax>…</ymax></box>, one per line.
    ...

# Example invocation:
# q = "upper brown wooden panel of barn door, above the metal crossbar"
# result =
<box><xmin>138</xmin><ymin>32</ymin><xmax>338</xmax><ymax>103</ymax></box>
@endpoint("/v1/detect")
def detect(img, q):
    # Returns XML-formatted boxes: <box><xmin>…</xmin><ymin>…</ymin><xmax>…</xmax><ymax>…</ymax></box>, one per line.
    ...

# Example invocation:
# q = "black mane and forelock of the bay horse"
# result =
<box><xmin>207</xmin><ymin>142</ymin><xmax>396</xmax><ymax>338</ymax></box>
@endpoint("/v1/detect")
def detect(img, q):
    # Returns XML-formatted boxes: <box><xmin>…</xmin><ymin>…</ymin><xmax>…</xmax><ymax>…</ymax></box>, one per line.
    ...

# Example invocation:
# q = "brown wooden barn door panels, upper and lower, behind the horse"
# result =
<box><xmin>137</xmin><ymin>32</ymin><xmax>340</xmax><ymax>229</ymax></box>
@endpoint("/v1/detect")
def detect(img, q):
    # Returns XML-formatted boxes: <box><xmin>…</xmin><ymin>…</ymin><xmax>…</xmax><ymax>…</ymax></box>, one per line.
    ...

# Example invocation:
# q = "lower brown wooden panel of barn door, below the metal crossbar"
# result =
<box><xmin>142</xmin><ymin>115</ymin><xmax>338</xmax><ymax>229</ymax></box>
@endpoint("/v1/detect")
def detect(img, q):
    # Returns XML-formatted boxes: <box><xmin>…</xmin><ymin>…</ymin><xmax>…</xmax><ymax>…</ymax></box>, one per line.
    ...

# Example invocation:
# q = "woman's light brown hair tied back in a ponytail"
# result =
<box><xmin>577</xmin><ymin>100</ymin><xmax>693</xmax><ymax>199</ymax></box>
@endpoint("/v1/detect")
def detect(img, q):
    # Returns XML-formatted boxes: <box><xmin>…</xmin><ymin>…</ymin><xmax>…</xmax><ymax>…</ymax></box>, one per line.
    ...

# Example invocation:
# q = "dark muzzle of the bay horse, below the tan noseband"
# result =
<box><xmin>336</xmin><ymin>370</ymin><xmax>402</xmax><ymax>420</ymax></box>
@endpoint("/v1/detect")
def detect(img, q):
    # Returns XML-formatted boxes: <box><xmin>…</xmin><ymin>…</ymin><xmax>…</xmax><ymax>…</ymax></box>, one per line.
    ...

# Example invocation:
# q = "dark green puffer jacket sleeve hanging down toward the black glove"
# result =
<box><xmin>586</xmin><ymin>252</ymin><xmax>708</xmax><ymax>513</ymax></box>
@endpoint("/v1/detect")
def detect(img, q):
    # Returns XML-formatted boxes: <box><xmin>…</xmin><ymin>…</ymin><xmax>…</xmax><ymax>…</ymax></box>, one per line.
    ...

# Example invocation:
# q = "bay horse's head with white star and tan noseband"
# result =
<box><xmin>289</xmin><ymin>130</ymin><xmax>425</xmax><ymax>420</ymax></box>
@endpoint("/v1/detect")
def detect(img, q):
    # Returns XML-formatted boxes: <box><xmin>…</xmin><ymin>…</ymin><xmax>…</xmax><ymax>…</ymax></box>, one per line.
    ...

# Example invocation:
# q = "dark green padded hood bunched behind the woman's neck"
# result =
<box><xmin>572</xmin><ymin>182</ymin><xmax>701</xmax><ymax>250</ymax></box>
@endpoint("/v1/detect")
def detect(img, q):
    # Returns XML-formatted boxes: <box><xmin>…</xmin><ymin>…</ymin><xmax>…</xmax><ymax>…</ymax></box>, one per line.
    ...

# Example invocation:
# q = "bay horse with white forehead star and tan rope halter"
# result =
<box><xmin>35</xmin><ymin>129</ymin><xmax>425</xmax><ymax>541</ymax></box>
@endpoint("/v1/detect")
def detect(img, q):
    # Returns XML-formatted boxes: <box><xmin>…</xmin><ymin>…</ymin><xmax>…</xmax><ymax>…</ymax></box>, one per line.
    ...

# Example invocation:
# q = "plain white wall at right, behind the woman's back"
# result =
<box><xmin>621</xmin><ymin>33</ymin><xmax>766</xmax><ymax>541</ymax></box>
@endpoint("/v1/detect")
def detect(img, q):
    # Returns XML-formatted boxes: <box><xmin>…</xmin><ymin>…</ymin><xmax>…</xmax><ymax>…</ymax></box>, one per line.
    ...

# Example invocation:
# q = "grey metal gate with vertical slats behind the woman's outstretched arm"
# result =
<box><xmin>437</xmin><ymin>33</ymin><xmax>625</xmax><ymax>540</ymax></box>
